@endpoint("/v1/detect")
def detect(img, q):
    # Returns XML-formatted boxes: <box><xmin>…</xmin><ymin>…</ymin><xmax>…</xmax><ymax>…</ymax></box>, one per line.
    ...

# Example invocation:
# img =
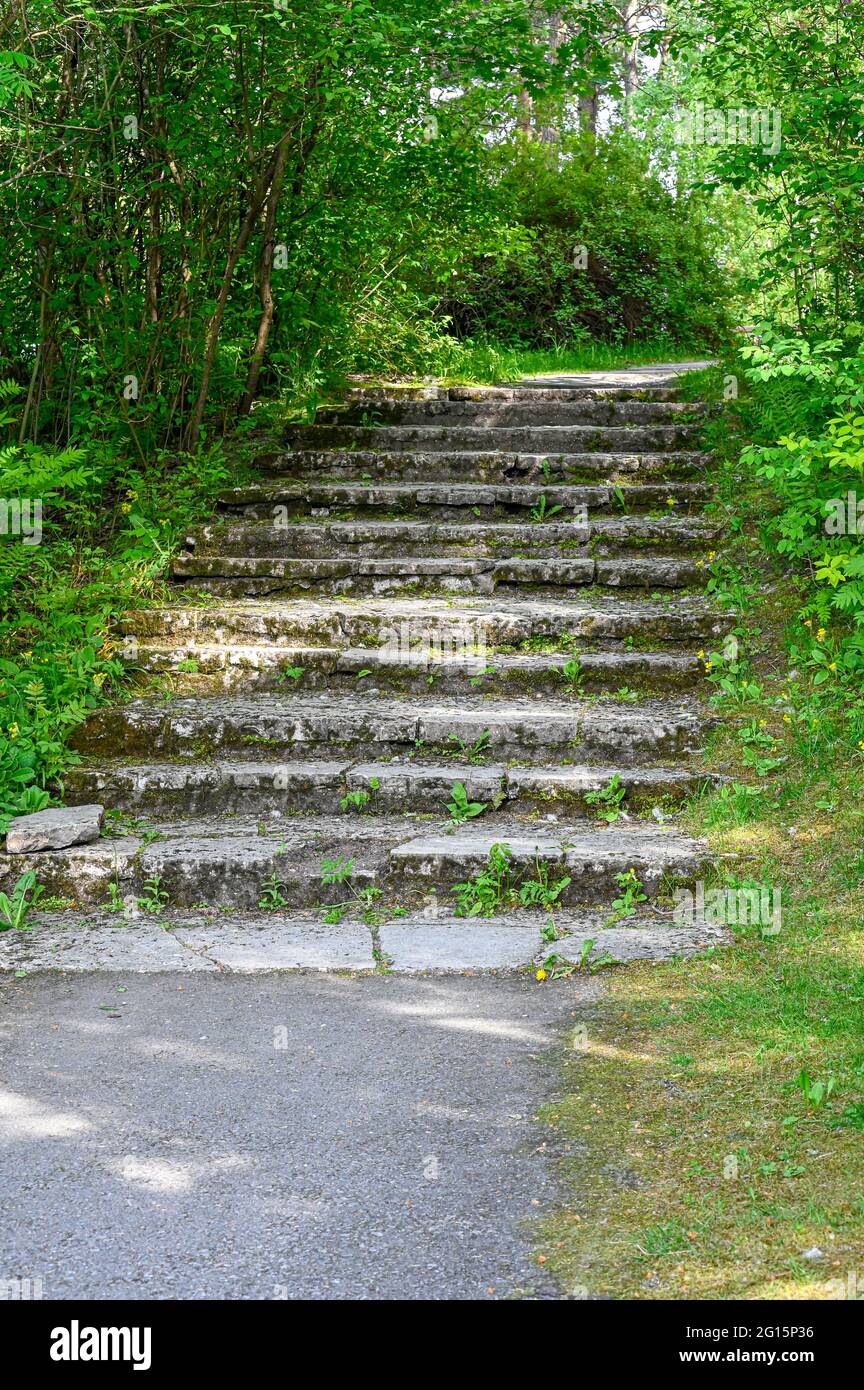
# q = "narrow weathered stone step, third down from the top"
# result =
<box><xmin>286</xmin><ymin>424</ymin><xmax>701</xmax><ymax>453</ymax></box>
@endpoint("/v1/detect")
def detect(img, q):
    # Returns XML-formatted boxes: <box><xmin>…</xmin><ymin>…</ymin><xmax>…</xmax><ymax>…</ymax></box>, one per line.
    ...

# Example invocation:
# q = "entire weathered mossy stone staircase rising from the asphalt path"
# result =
<box><xmin>0</xmin><ymin>371</ymin><xmax>725</xmax><ymax>969</ymax></box>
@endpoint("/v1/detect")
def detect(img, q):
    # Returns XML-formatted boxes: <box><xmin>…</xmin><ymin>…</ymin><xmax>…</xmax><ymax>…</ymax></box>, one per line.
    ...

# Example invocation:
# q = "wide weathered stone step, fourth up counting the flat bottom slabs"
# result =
<box><xmin>74</xmin><ymin>694</ymin><xmax>706</xmax><ymax>765</ymax></box>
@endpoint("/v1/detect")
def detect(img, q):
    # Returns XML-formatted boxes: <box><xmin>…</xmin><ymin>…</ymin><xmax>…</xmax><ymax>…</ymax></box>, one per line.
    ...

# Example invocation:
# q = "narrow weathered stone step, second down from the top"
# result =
<box><xmin>315</xmin><ymin>396</ymin><xmax>707</xmax><ymax>430</ymax></box>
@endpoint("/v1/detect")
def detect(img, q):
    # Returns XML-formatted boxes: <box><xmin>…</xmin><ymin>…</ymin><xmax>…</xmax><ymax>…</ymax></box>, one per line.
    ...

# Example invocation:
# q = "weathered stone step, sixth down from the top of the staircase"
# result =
<box><xmin>186</xmin><ymin>516</ymin><xmax>720</xmax><ymax>560</ymax></box>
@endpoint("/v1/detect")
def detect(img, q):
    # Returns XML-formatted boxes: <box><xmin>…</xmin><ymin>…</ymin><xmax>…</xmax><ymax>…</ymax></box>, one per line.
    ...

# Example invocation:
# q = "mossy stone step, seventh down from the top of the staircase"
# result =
<box><xmin>171</xmin><ymin>555</ymin><xmax>703</xmax><ymax>598</ymax></box>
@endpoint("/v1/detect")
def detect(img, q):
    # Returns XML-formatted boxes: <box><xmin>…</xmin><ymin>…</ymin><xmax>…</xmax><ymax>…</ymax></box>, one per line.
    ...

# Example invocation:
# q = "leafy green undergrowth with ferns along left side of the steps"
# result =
<box><xmin>0</xmin><ymin>382</ymin><xmax>237</xmax><ymax>834</ymax></box>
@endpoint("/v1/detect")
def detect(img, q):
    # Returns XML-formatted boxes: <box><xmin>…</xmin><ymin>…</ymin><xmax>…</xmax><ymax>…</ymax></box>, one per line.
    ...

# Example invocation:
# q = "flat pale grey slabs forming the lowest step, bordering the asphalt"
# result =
<box><xmin>0</xmin><ymin>894</ymin><xmax>726</xmax><ymax>976</ymax></box>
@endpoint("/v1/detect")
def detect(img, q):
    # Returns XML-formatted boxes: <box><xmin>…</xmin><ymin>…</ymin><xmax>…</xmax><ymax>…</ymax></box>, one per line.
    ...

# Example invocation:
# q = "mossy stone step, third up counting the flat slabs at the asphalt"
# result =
<box><xmin>64</xmin><ymin>759</ymin><xmax>710</xmax><ymax>826</ymax></box>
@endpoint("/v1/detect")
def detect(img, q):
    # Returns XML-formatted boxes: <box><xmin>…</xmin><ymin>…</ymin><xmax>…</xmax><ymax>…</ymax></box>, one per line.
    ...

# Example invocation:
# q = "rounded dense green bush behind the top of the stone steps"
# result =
<box><xmin>442</xmin><ymin>135</ymin><xmax>731</xmax><ymax>348</ymax></box>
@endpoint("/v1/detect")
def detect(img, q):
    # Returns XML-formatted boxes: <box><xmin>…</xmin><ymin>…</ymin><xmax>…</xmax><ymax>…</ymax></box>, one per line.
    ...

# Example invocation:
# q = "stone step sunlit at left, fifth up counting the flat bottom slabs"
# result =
<box><xmin>126</xmin><ymin>634</ymin><xmax>704</xmax><ymax>696</ymax></box>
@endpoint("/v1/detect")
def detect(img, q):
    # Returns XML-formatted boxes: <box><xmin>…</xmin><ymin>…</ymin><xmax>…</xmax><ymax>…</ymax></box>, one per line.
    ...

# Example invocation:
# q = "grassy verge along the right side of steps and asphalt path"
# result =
<box><xmin>538</xmin><ymin>363</ymin><xmax>864</xmax><ymax>1300</ymax></box>
